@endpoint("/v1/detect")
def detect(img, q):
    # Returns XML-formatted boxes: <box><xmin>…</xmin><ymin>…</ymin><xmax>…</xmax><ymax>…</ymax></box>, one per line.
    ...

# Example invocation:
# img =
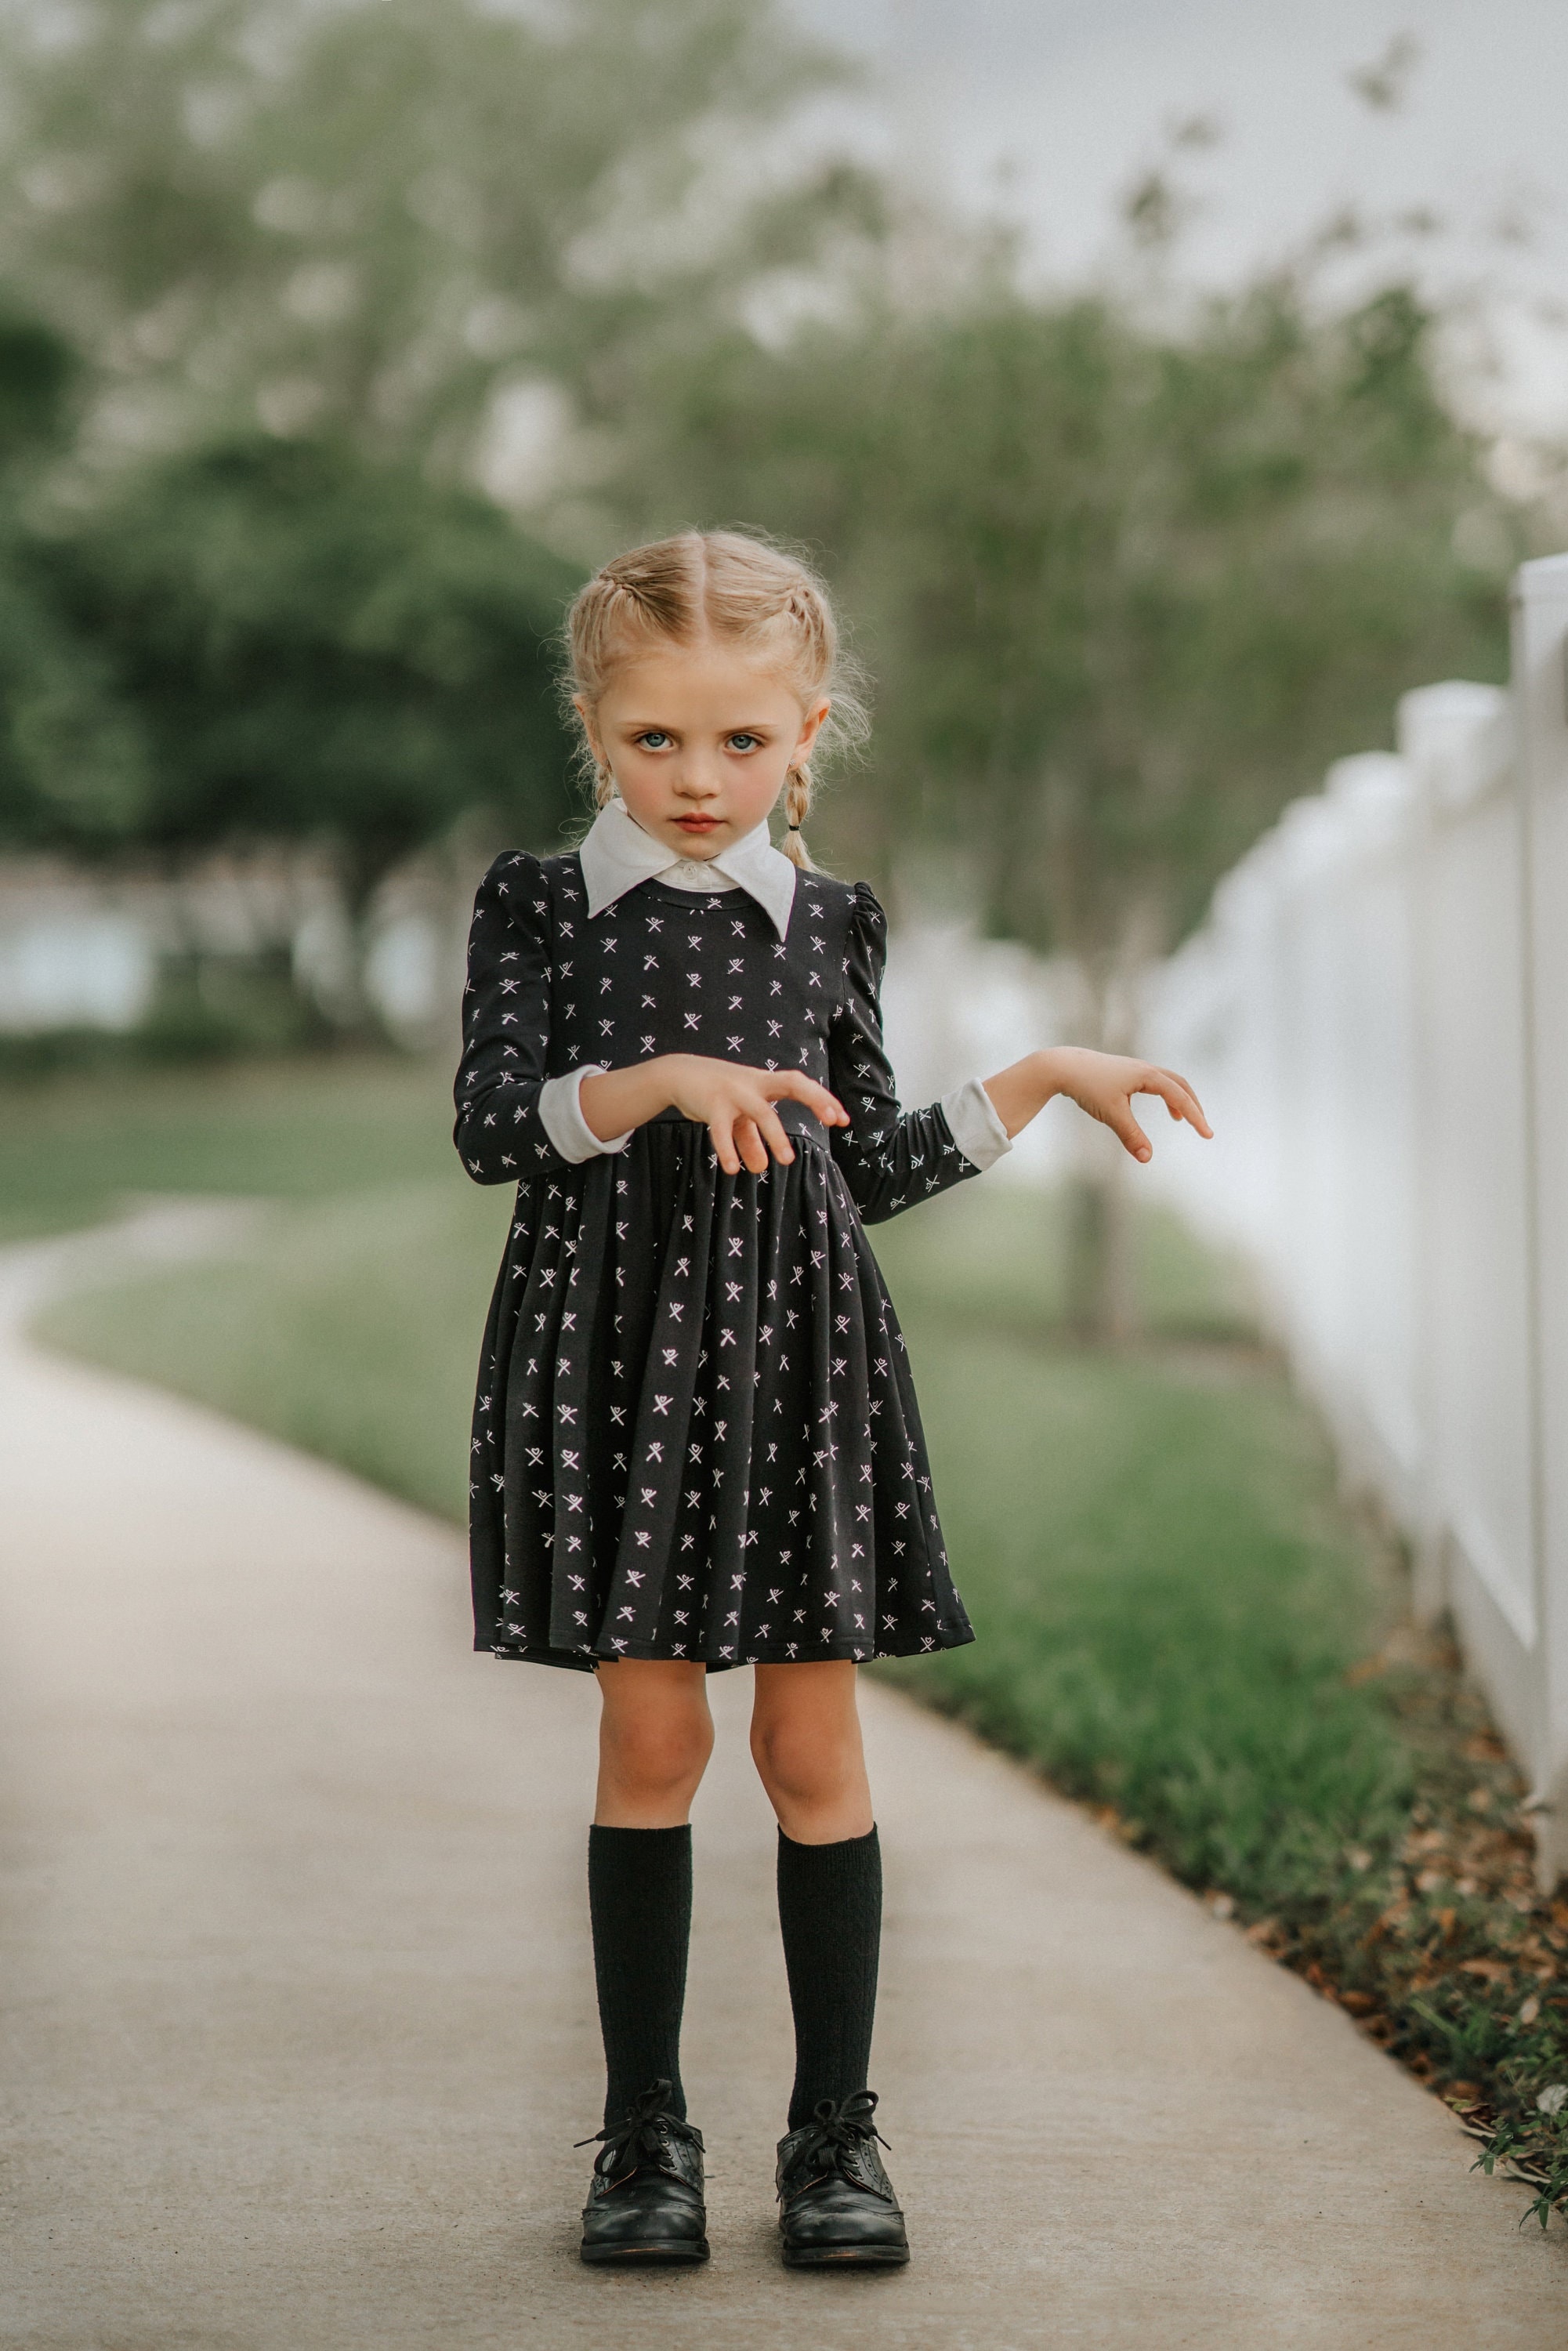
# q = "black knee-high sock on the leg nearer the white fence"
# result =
<box><xmin>778</xmin><ymin>1829</ymin><xmax>882</xmax><ymax>2130</ymax></box>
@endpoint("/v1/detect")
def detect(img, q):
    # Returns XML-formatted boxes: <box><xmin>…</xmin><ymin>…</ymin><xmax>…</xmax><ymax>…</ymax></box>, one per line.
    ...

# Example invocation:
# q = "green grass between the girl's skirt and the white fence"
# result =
<box><xmin>870</xmin><ymin>1314</ymin><xmax>1408</xmax><ymax>1902</ymax></box>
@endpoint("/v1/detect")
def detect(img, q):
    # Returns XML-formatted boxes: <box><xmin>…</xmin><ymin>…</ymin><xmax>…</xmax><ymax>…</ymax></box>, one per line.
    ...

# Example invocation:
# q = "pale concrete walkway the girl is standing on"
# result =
<box><xmin>0</xmin><ymin>1223</ymin><xmax>1568</xmax><ymax>2351</ymax></box>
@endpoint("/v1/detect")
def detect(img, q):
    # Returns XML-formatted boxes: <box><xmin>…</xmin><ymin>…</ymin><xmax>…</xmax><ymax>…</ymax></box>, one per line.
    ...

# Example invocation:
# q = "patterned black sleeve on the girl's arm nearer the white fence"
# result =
<box><xmin>827</xmin><ymin>882</ymin><xmax>980</xmax><ymax>1225</ymax></box>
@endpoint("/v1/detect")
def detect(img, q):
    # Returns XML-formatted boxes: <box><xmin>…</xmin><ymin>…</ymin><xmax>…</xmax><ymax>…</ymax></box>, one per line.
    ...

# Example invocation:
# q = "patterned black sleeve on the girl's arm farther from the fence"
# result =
<box><xmin>451</xmin><ymin>853</ymin><xmax>583</xmax><ymax>1183</ymax></box>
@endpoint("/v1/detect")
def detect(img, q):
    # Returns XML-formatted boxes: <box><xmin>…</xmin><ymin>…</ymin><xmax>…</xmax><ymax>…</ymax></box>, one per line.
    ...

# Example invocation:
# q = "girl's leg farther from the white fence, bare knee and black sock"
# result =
<box><xmin>588</xmin><ymin>1657</ymin><xmax>712</xmax><ymax>2128</ymax></box>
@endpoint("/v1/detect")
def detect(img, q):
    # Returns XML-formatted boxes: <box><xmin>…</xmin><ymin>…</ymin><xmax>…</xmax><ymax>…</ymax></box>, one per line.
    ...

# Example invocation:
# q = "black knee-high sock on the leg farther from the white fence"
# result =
<box><xmin>588</xmin><ymin>1822</ymin><xmax>691</xmax><ymax>2128</ymax></box>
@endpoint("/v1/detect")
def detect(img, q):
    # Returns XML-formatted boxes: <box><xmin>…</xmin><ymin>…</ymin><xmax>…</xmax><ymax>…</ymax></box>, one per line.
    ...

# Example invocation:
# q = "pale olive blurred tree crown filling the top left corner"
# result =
<box><xmin>0</xmin><ymin>0</ymin><xmax>875</xmax><ymax>473</ymax></box>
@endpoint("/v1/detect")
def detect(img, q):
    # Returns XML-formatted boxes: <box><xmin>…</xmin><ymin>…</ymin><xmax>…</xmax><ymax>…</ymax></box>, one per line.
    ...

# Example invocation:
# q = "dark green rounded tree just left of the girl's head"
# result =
<box><xmin>52</xmin><ymin>437</ymin><xmax>578</xmax><ymax>1020</ymax></box>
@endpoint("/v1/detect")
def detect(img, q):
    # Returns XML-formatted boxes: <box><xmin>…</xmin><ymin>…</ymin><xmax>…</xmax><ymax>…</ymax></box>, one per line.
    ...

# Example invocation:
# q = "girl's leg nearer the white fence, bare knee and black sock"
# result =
<box><xmin>752</xmin><ymin>1660</ymin><xmax>882</xmax><ymax>2130</ymax></box>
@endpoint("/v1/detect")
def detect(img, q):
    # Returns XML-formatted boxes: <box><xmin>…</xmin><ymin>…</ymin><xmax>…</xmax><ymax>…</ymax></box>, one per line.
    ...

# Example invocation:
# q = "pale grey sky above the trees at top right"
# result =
<box><xmin>790</xmin><ymin>0</ymin><xmax>1568</xmax><ymax>428</ymax></box>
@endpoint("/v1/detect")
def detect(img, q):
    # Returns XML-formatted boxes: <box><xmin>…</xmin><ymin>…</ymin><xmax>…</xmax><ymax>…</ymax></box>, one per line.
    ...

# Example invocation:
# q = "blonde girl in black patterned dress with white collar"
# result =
<box><xmin>456</xmin><ymin>531</ymin><xmax>1208</xmax><ymax>2266</ymax></box>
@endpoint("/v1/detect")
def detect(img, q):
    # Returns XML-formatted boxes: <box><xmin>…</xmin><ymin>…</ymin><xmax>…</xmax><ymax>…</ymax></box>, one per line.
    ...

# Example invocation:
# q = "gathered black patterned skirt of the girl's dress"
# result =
<box><xmin>470</xmin><ymin>1119</ymin><xmax>973</xmax><ymax>1672</ymax></box>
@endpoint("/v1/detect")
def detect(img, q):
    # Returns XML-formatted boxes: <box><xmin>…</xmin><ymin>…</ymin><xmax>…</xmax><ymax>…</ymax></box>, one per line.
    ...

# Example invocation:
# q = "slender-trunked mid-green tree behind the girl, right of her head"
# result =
<box><xmin>607</xmin><ymin>273</ymin><xmax>1523</xmax><ymax>1328</ymax></box>
